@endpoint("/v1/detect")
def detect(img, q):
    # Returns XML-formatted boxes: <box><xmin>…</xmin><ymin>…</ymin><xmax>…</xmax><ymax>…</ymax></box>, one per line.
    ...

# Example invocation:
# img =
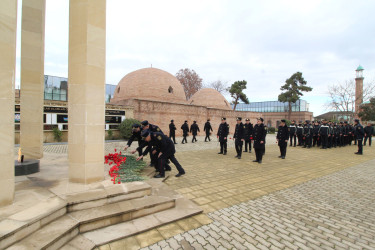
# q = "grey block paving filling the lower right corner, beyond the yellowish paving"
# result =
<box><xmin>144</xmin><ymin>160</ymin><xmax>375</xmax><ymax>249</ymax></box>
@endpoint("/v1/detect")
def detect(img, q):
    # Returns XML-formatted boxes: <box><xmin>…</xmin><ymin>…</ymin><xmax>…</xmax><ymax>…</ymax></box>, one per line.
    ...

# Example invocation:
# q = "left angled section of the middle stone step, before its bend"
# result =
<box><xmin>7</xmin><ymin>215</ymin><xmax>79</xmax><ymax>250</ymax></box>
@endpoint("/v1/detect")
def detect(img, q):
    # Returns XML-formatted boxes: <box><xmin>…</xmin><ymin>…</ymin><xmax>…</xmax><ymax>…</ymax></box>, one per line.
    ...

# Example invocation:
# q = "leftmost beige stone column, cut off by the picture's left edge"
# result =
<box><xmin>0</xmin><ymin>0</ymin><xmax>17</xmax><ymax>207</ymax></box>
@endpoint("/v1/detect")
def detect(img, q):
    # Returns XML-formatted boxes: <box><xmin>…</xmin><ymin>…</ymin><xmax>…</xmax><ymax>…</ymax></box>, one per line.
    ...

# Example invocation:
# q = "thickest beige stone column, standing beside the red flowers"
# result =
<box><xmin>68</xmin><ymin>0</ymin><xmax>106</xmax><ymax>184</ymax></box>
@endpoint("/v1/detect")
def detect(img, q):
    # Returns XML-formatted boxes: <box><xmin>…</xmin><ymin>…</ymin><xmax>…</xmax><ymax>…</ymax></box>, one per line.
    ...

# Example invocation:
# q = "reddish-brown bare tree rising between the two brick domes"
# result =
<box><xmin>176</xmin><ymin>69</ymin><xmax>202</xmax><ymax>100</ymax></box>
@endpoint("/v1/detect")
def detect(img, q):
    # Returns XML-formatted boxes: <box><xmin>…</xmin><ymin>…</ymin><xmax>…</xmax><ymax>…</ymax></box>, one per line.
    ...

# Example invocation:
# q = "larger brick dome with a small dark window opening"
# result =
<box><xmin>111</xmin><ymin>68</ymin><xmax>186</xmax><ymax>103</ymax></box>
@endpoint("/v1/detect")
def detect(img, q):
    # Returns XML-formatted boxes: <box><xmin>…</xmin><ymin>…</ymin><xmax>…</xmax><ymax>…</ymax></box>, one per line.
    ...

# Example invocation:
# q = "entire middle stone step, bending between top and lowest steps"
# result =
<box><xmin>5</xmin><ymin>196</ymin><xmax>175</xmax><ymax>249</ymax></box>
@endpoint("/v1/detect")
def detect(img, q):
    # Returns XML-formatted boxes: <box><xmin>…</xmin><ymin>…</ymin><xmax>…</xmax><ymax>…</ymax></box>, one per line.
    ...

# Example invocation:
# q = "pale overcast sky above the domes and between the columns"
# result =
<box><xmin>17</xmin><ymin>0</ymin><xmax>375</xmax><ymax>115</ymax></box>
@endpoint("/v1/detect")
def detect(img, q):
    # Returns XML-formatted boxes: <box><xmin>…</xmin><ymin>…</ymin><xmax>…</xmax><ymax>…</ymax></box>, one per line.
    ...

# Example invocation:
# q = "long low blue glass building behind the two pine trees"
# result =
<box><xmin>232</xmin><ymin>100</ymin><xmax>309</xmax><ymax>113</ymax></box>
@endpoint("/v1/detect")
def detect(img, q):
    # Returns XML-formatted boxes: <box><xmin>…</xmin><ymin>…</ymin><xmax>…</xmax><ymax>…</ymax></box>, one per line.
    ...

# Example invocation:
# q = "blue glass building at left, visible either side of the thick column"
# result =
<box><xmin>44</xmin><ymin>75</ymin><xmax>116</xmax><ymax>103</ymax></box>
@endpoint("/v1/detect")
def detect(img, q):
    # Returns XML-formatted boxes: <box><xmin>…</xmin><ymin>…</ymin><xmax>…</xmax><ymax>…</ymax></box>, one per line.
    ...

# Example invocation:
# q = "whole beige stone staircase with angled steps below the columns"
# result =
<box><xmin>0</xmin><ymin>180</ymin><xmax>202</xmax><ymax>249</ymax></box>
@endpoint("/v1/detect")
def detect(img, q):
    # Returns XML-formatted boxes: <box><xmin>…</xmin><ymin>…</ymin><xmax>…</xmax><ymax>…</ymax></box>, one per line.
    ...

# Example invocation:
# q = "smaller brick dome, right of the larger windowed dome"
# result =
<box><xmin>189</xmin><ymin>88</ymin><xmax>231</xmax><ymax>110</ymax></box>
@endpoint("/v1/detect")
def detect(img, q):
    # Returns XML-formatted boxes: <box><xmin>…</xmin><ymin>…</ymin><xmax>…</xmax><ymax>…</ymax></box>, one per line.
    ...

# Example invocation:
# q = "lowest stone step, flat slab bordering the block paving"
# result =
<box><xmin>75</xmin><ymin>198</ymin><xmax>202</xmax><ymax>250</ymax></box>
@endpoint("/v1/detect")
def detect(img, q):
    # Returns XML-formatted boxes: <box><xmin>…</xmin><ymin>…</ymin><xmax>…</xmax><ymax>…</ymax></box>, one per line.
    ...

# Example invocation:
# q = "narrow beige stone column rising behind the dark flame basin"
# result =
<box><xmin>20</xmin><ymin>0</ymin><xmax>46</xmax><ymax>159</ymax></box>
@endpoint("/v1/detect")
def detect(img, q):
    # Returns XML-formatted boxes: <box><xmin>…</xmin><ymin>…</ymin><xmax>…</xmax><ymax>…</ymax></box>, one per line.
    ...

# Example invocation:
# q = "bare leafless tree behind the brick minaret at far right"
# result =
<box><xmin>326</xmin><ymin>79</ymin><xmax>375</xmax><ymax>121</ymax></box>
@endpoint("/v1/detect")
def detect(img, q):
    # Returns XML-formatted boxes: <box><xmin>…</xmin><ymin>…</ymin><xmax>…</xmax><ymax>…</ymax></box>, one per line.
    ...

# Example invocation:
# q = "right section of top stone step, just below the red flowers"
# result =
<box><xmin>64</xmin><ymin>182</ymin><xmax>151</xmax><ymax>212</ymax></box>
